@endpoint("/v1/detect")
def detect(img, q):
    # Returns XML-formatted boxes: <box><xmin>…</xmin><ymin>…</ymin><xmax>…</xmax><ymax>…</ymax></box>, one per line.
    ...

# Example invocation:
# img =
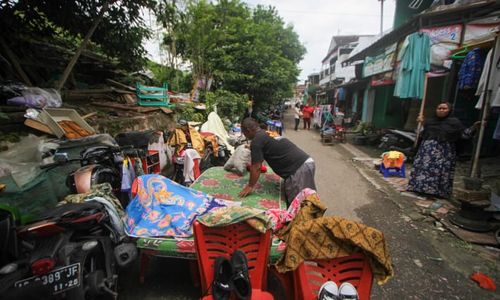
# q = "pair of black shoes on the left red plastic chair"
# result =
<box><xmin>212</xmin><ymin>250</ymin><xmax>252</xmax><ymax>300</ymax></box>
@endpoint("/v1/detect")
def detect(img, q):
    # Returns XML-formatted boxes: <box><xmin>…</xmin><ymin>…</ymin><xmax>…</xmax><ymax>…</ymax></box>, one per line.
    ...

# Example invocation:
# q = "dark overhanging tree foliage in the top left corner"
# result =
<box><xmin>0</xmin><ymin>0</ymin><xmax>156</xmax><ymax>70</ymax></box>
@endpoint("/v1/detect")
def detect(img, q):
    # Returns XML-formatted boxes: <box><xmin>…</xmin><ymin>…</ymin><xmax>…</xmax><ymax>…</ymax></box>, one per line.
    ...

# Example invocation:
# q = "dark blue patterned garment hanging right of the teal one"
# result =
<box><xmin>458</xmin><ymin>48</ymin><xmax>484</xmax><ymax>90</ymax></box>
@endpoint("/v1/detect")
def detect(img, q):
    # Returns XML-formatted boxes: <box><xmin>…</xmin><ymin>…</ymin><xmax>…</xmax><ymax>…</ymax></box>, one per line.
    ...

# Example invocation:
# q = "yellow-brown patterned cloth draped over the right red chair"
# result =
<box><xmin>276</xmin><ymin>195</ymin><xmax>394</xmax><ymax>284</ymax></box>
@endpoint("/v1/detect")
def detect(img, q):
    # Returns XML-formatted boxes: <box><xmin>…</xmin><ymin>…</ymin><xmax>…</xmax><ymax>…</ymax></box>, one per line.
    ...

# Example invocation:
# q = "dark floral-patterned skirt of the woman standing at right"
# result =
<box><xmin>408</xmin><ymin>140</ymin><xmax>456</xmax><ymax>198</ymax></box>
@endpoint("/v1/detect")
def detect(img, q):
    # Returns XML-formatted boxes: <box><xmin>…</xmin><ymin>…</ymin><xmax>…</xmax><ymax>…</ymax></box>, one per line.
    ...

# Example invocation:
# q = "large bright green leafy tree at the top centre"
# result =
<box><xmin>165</xmin><ymin>0</ymin><xmax>305</xmax><ymax>106</ymax></box>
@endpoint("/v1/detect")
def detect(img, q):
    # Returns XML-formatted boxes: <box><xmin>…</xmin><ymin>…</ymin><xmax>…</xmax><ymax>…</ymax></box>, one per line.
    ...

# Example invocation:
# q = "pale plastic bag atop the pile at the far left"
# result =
<box><xmin>7</xmin><ymin>87</ymin><xmax>62</xmax><ymax>108</ymax></box>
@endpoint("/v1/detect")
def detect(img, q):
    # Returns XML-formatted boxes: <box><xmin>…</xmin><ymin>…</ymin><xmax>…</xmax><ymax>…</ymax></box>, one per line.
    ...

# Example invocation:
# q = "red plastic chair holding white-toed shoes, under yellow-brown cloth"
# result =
<box><xmin>293</xmin><ymin>253</ymin><xmax>373</xmax><ymax>300</ymax></box>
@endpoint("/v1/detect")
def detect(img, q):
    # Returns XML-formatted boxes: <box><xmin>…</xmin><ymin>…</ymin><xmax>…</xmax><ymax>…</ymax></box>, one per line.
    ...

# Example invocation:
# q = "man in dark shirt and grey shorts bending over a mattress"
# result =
<box><xmin>239</xmin><ymin>118</ymin><xmax>316</xmax><ymax>204</ymax></box>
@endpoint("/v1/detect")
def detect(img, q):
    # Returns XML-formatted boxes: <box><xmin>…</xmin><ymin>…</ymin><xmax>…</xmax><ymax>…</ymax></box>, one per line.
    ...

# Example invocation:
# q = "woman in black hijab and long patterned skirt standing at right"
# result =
<box><xmin>408</xmin><ymin>102</ymin><xmax>477</xmax><ymax>198</ymax></box>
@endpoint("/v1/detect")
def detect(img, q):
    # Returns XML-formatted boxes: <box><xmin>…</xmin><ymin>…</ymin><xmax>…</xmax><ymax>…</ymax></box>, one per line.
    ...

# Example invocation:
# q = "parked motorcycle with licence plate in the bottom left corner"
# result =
<box><xmin>0</xmin><ymin>202</ymin><xmax>137</xmax><ymax>299</ymax></box>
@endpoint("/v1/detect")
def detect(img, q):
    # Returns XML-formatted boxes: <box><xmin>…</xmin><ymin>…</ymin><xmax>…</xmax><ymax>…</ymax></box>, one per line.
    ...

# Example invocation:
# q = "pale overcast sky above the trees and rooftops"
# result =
<box><xmin>145</xmin><ymin>0</ymin><xmax>395</xmax><ymax>81</ymax></box>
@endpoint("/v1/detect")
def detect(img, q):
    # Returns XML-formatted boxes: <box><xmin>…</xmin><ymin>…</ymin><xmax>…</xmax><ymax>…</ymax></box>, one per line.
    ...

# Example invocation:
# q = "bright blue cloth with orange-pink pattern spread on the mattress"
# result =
<box><xmin>125</xmin><ymin>174</ymin><xmax>215</xmax><ymax>237</ymax></box>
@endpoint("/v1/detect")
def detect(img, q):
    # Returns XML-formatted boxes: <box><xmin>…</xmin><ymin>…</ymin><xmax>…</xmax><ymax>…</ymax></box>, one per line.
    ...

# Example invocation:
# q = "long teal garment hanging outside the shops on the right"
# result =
<box><xmin>394</xmin><ymin>32</ymin><xmax>430</xmax><ymax>99</ymax></box>
